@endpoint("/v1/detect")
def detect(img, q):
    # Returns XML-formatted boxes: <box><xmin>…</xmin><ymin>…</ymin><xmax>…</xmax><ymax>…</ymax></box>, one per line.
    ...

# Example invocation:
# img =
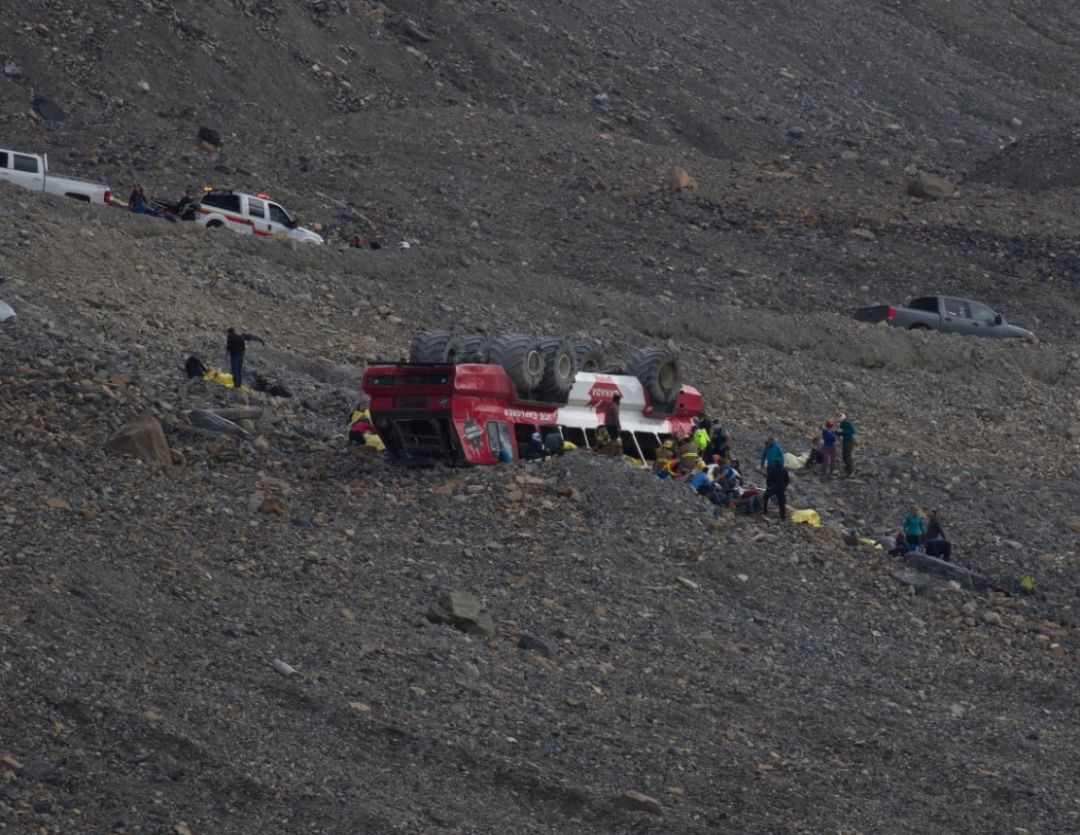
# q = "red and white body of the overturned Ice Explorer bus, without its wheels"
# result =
<box><xmin>362</xmin><ymin>363</ymin><xmax>702</xmax><ymax>464</ymax></box>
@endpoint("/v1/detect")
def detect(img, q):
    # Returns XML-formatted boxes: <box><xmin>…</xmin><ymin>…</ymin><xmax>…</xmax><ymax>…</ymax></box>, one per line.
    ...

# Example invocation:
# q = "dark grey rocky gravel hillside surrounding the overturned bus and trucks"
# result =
<box><xmin>0</xmin><ymin>0</ymin><xmax>1080</xmax><ymax>835</ymax></box>
